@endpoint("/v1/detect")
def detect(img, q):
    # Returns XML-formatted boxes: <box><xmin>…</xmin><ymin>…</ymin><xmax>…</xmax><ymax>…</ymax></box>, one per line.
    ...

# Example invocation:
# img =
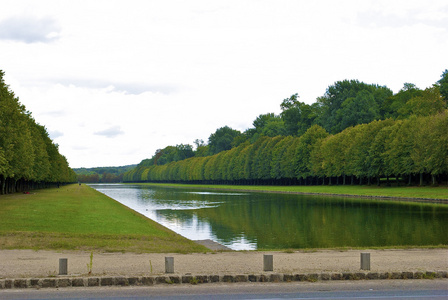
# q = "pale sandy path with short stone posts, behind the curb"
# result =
<box><xmin>0</xmin><ymin>249</ymin><xmax>448</xmax><ymax>278</ymax></box>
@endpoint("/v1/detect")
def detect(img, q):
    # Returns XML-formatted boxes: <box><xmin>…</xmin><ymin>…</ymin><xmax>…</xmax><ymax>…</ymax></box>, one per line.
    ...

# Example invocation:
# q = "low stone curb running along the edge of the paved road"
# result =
<box><xmin>0</xmin><ymin>271</ymin><xmax>448</xmax><ymax>290</ymax></box>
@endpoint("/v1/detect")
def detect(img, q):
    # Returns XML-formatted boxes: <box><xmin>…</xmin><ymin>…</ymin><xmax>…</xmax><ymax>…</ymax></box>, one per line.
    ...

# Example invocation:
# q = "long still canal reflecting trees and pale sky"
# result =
<box><xmin>90</xmin><ymin>184</ymin><xmax>448</xmax><ymax>250</ymax></box>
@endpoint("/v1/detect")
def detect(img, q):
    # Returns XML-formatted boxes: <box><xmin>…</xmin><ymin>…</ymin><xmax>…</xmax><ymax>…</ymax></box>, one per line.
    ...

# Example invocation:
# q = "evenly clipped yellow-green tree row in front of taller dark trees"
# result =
<box><xmin>124</xmin><ymin>111</ymin><xmax>448</xmax><ymax>184</ymax></box>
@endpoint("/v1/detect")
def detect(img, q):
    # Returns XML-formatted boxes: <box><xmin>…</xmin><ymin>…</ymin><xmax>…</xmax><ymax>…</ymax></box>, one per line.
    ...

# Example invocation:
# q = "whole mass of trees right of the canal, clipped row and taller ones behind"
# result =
<box><xmin>123</xmin><ymin>70</ymin><xmax>448</xmax><ymax>184</ymax></box>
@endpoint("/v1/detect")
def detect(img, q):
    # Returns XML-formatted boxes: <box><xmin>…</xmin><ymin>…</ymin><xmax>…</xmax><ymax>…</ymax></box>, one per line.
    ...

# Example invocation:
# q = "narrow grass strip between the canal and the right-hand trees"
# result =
<box><xmin>131</xmin><ymin>183</ymin><xmax>448</xmax><ymax>199</ymax></box>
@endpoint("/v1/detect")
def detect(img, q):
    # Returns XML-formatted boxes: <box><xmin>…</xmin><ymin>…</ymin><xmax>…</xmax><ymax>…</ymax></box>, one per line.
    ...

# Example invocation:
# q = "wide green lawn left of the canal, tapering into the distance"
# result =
<box><xmin>0</xmin><ymin>184</ymin><xmax>207</xmax><ymax>253</ymax></box>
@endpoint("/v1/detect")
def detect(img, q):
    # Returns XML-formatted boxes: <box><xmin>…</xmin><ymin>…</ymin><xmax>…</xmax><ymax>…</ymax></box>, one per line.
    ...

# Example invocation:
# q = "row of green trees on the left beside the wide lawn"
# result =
<box><xmin>0</xmin><ymin>70</ymin><xmax>76</xmax><ymax>194</ymax></box>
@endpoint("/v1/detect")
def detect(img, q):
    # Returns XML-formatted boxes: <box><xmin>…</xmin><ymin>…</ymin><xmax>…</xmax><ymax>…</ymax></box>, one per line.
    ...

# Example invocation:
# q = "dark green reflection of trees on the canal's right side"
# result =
<box><xmin>193</xmin><ymin>198</ymin><xmax>448</xmax><ymax>249</ymax></box>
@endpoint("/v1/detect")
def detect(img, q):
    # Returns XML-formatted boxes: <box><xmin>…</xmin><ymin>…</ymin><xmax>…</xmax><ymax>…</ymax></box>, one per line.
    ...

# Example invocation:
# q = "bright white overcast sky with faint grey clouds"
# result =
<box><xmin>0</xmin><ymin>0</ymin><xmax>448</xmax><ymax>168</ymax></box>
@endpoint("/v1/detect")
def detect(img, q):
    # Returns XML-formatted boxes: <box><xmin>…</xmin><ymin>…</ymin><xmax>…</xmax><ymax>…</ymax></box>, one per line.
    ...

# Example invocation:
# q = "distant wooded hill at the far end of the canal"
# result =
<box><xmin>73</xmin><ymin>165</ymin><xmax>137</xmax><ymax>183</ymax></box>
